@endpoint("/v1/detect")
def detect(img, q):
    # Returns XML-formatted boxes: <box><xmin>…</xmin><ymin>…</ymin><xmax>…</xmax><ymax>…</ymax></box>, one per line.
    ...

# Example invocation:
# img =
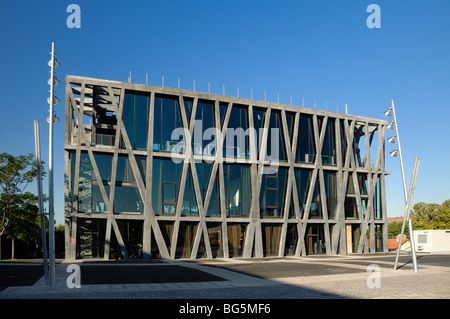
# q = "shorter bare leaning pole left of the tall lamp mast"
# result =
<box><xmin>34</xmin><ymin>120</ymin><xmax>49</xmax><ymax>285</ymax></box>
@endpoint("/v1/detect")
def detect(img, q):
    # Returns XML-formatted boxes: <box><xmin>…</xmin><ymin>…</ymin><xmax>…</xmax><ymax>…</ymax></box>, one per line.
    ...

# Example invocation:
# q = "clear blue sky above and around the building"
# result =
<box><xmin>0</xmin><ymin>0</ymin><xmax>450</xmax><ymax>223</ymax></box>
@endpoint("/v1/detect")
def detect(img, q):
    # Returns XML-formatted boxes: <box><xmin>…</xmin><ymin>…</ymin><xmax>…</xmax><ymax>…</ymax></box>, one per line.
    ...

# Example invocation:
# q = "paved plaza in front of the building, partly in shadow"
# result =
<box><xmin>0</xmin><ymin>253</ymin><xmax>450</xmax><ymax>299</ymax></box>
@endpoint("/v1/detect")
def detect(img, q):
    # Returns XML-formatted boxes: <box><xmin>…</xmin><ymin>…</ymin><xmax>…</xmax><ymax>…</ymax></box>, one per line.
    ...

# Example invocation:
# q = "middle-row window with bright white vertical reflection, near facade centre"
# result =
<box><xmin>223</xmin><ymin>164</ymin><xmax>251</xmax><ymax>217</ymax></box>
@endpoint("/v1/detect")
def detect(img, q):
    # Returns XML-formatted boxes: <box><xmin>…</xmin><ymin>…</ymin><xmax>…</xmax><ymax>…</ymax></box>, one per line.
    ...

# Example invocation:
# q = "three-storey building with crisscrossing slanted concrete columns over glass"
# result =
<box><xmin>64</xmin><ymin>76</ymin><xmax>389</xmax><ymax>259</ymax></box>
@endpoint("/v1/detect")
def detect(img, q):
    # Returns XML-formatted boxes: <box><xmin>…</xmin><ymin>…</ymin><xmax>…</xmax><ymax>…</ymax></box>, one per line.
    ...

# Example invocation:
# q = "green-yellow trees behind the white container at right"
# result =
<box><xmin>411</xmin><ymin>199</ymin><xmax>450</xmax><ymax>229</ymax></box>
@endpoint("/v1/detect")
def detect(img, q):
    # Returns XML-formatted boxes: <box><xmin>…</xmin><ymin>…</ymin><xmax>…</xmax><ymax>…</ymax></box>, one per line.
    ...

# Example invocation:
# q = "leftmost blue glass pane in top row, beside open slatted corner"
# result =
<box><xmin>121</xmin><ymin>91</ymin><xmax>150</xmax><ymax>150</ymax></box>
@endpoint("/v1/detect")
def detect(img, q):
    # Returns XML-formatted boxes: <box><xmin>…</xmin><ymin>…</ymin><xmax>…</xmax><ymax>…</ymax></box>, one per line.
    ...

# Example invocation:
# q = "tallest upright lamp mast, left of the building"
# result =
<box><xmin>48</xmin><ymin>42</ymin><xmax>55</xmax><ymax>289</ymax></box>
